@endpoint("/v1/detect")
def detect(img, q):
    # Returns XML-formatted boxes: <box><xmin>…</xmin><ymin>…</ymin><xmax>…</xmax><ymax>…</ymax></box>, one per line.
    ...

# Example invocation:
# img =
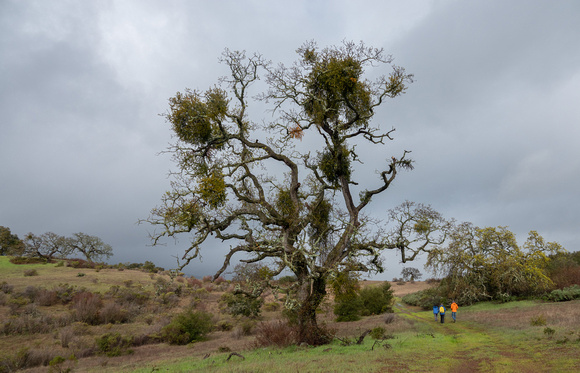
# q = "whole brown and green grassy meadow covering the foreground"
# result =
<box><xmin>0</xmin><ymin>257</ymin><xmax>580</xmax><ymax>373</ymax></box>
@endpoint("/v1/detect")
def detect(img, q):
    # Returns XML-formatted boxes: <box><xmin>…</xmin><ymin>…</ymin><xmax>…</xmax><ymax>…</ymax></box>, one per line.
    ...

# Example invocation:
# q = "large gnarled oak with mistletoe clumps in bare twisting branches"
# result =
<box><xmin>148</xmin><ymin>42</ymin><xmax>444</xmax><ymax>344</ymax></box>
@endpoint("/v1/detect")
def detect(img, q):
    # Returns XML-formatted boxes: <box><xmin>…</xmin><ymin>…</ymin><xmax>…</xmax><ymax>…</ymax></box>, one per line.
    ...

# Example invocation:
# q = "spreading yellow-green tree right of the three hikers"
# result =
<box><xmin>427</xmin><ymin>223</ymin><xmax>564</xmax><ymax>303</ymax></box>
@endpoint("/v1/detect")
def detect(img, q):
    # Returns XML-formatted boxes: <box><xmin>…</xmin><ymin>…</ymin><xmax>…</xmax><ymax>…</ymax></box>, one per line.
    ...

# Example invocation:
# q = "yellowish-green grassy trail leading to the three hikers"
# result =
<box><xmin>395</xmin><ymin>303</ymin><xmax>550</xmax><ymax>372</ymax></box>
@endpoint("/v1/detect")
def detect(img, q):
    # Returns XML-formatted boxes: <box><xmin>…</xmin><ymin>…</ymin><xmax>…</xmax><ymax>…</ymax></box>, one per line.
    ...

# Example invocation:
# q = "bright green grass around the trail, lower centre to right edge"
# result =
<box><xmin>93</xmin><ymin>301</ymin><xmax>580</xmax><ymax>372</ymax></box>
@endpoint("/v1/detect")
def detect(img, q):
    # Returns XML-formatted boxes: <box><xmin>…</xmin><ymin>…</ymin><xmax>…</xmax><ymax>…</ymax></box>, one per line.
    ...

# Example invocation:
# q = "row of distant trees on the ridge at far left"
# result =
<box><xmin>0</xmin><ymin>226</ymin><xmax>113</xmax><ymax>262</ymax></box>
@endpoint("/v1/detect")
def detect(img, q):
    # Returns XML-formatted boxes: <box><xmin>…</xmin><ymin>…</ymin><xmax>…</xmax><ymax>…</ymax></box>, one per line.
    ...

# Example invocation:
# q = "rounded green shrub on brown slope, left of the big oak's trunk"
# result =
<box><xmin>161</xmin><ymin>308</ymin><xmax>213</xmax><ymax>345</ymax></box>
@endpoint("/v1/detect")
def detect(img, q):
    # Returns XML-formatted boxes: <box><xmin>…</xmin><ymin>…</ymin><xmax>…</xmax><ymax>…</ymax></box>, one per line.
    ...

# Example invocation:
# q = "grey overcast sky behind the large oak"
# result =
<box><xmin>0</xmin><ymin>0</ymin><xmax>580</xmax><ymax>280</ymax></box>
